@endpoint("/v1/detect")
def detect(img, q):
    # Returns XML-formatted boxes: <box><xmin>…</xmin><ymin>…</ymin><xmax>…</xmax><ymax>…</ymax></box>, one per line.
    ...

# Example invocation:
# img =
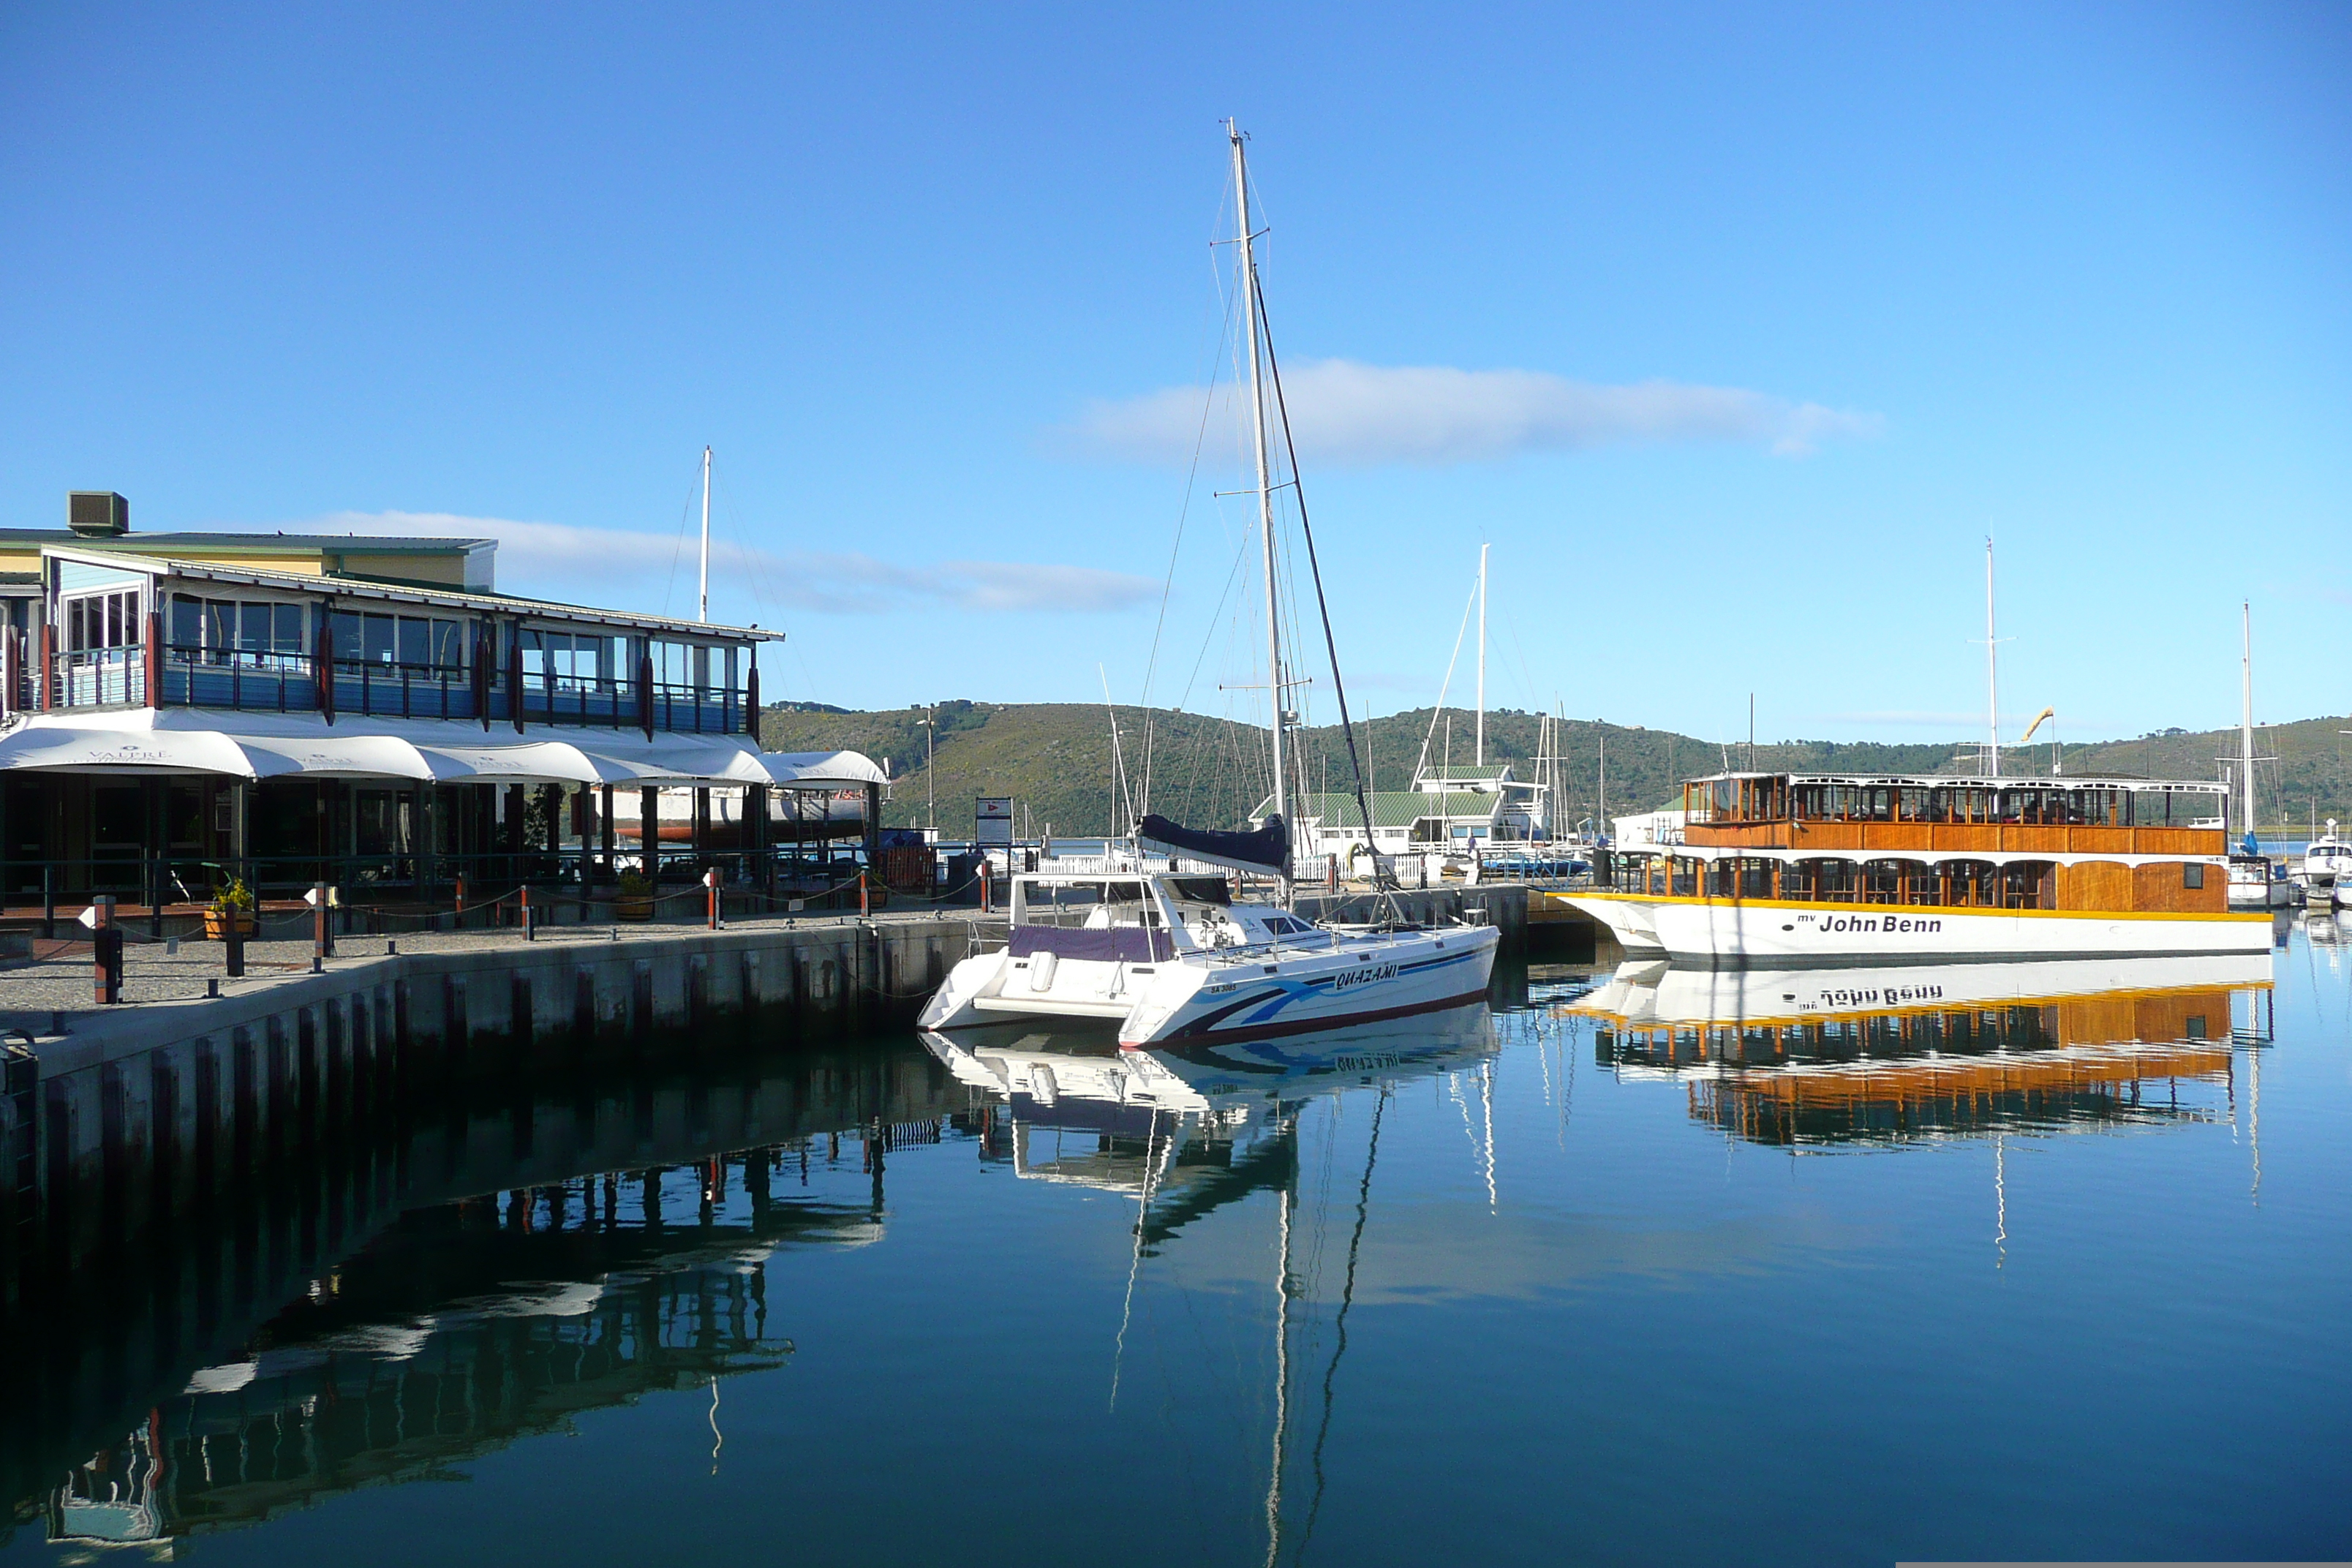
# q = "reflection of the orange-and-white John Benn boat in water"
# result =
<box><xmin>1561</xmin><ymin>952</ymin><xmax>2272</xmax><ymax>1147</ymax></box>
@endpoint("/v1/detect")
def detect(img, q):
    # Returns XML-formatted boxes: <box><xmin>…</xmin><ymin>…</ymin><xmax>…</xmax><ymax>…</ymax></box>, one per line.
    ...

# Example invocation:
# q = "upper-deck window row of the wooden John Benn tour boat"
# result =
<box><xmin>1684</xmin><ymin>778</ymin><xmax>2220</xmax><ymax>827</ymax></box>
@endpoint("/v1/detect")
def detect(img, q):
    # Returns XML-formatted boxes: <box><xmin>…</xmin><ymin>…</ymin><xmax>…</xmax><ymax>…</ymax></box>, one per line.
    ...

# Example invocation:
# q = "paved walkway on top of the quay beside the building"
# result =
<box><xmin>0</xmin><ymin>908</ymin><xmax>1002</xmax><ymax>1034</ymax></box>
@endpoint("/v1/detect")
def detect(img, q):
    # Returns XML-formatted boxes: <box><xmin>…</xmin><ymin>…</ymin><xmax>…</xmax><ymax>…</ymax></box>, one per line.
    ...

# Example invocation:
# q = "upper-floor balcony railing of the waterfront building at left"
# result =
<box><xmin>10</xmin><ymin>644</ymin><xmax>750</xmax><ymax>736</ymax></box>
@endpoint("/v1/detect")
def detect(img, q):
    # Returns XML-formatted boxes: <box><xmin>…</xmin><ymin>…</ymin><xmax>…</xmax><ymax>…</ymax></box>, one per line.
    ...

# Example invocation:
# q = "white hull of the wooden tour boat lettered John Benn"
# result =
<box><xmin>1569</xmin><ymin>893</ymin><xmax>2269</xmax><ymax>964</ymax></box>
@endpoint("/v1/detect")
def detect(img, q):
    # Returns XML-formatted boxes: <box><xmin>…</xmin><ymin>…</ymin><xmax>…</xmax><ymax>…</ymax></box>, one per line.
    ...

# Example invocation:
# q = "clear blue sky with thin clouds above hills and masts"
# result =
<box><xmin>0</xmin><ymin>4</ymin><xmax>2352</xmax><ymax>738</ymax></box>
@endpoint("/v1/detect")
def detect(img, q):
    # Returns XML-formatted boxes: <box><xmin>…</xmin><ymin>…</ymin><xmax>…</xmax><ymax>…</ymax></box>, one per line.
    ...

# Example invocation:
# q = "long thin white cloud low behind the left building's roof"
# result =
<box><xmin>298</xmin><ymin>513</ymin><xmax>1159</xmax><ymax>616</ymax></box>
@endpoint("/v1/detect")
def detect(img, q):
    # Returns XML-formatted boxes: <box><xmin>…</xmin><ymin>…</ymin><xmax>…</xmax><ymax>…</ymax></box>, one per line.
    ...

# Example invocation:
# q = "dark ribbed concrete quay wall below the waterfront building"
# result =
<box><xmin>0</xmin><ymin>914</ymin><xmax>1002</xmax><ymax>1307</ymax></box>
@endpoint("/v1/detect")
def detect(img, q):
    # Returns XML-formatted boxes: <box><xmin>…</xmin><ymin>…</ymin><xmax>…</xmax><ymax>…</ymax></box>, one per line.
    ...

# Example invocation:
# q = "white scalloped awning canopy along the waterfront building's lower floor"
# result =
<box><xmin>0</xmin><ymin>708</ymin><xmax>882</xmax><ymax>790</ymax></box>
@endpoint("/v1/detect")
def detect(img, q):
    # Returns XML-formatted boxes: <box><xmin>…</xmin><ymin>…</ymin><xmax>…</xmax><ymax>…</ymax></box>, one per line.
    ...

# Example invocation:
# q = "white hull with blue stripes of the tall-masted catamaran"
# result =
<box><xmin>917</xmin><ymin>926</ymin><xmax>1501</xmax><ymax>1046</ymax></box>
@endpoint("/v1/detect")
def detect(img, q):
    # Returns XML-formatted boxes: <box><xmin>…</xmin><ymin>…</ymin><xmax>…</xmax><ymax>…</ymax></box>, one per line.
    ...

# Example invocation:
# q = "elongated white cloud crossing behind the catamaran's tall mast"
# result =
<box><xmin>1075</xmin><ymin>360</ymin><xmax>1884</xmax><ymax>465</ymax></box>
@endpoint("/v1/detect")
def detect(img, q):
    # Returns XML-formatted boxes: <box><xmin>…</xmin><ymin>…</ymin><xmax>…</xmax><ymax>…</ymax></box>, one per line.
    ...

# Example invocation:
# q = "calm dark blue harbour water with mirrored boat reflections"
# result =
<box><xmin>0</xmin><ymin>926</ymin><xmax>2352</xmax><ymax>1566</ymax></box>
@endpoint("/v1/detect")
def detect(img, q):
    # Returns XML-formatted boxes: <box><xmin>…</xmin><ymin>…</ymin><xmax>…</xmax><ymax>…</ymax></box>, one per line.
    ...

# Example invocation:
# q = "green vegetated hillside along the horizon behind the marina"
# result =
<box><xmin>762</xmin><ymin>701</ymin><xmax>2352</xmax><ymax>837</ymax></box>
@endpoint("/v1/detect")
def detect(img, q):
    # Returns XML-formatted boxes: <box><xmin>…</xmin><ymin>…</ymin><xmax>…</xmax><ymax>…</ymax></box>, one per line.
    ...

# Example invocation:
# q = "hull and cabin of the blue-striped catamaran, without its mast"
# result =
<box><xmin>917</xmin><ymin>864</ymin><xmax>1501</xmax><ymax>1046</ymax></box>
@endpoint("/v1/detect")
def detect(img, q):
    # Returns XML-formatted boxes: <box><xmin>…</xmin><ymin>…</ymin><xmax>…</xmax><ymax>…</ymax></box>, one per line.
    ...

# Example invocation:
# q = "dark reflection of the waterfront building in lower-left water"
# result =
<box><xmin>4</xmin><ymin>1053</ymin><xmax>981</xmax><ymax>1551</ymax></box>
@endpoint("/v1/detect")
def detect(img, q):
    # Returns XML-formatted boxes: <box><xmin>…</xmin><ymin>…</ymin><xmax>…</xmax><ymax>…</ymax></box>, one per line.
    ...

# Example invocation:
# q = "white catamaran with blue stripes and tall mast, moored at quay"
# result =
<box><xmin>919</xmin><ymin>124</ymin><xmax>1501</xmax><ymax>1046</ymax></box>
